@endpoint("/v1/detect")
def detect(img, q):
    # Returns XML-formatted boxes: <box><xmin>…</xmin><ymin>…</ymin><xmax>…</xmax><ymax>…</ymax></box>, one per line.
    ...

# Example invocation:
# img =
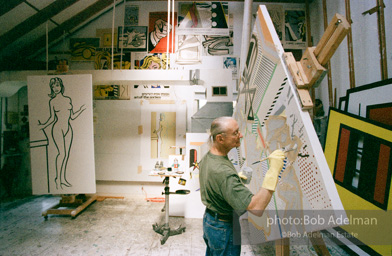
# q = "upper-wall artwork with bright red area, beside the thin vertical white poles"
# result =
<box><xmin>148</xmin><ymin>12</ymin><xmax>177</xmax><ymax>53</ymax></box>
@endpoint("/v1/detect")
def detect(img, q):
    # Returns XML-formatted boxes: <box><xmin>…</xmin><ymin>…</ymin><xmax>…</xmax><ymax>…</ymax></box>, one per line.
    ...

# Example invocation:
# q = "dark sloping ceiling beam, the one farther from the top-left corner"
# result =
<box><xmin>21</xmin><ymin>0</ymin><xmax>113</xmax><ymax>57</ymax></box>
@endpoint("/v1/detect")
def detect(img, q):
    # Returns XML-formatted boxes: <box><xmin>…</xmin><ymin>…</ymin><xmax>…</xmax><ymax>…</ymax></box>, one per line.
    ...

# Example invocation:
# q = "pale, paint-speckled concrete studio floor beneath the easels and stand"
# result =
<box><xmin>0</xmin><ymin>196</ymin><xmax>349</xmax><ymax>256</ymax></box>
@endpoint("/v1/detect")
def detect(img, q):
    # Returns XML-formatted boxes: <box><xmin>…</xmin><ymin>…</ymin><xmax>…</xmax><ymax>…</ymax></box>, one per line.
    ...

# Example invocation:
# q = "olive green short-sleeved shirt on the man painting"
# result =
<box><xmin>199</xmin><ymin>152</ymin><xmax>253</xmax><ymax>215</ymax></box>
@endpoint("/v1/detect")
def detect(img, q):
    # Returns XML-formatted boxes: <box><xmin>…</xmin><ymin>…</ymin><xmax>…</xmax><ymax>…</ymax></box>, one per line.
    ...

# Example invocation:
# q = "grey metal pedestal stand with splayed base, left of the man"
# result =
<box><xmin>152</xmin><ymin>177</ymin><xmax>189</xmax><ymax>244</ymax></box>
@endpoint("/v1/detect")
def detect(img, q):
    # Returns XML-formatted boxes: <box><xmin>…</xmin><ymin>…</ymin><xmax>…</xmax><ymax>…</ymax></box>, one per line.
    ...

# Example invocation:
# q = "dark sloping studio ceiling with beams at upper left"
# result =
<box><xmin>0</xmin><ymin>0</ymin><xmax>304</xmax><ymax>71</ymax></box>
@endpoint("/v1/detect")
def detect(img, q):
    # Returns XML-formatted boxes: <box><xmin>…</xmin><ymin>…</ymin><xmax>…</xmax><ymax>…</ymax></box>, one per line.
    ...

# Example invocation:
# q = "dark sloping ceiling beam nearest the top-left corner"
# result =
<box><xmin>0</xmin><ymin>0</ymin><xmax>79</xmax><ymax>49</ymax></box>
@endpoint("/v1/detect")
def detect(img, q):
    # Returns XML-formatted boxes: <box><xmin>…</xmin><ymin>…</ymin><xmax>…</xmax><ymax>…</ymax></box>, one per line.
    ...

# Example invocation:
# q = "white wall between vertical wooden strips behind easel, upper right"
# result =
<box><xmin>310</xmin><ymin>0</ymin><xmax>392</xmax><ymax>111</ymax></box>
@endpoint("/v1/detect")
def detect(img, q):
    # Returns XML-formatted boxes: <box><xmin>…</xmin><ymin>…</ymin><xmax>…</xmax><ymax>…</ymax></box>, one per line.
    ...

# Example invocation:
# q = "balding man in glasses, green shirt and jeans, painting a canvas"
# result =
<box><xmin>199</xmin><ymin>117</ymin><xmax>285</xmax><ymax>256</ymax></box>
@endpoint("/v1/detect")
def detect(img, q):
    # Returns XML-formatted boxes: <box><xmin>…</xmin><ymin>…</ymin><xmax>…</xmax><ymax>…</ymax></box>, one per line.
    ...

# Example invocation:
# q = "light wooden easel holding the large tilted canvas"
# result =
<box><xmin>275</xmin><ymin>14</ymin><xmax>350</xmax><ymax>256</ymax></box>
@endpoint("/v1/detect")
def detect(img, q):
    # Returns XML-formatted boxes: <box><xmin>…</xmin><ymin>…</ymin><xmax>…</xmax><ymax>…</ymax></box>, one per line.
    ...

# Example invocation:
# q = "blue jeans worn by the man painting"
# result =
<box><xmin>203</xmin><ymin>209</ymin><xmax>241</xmax><ymax>256</ymax></box>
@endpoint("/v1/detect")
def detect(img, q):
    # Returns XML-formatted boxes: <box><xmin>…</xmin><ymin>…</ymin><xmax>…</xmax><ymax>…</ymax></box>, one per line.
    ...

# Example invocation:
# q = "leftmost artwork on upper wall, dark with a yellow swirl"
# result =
<box><xmin>70</xmin><ymin>38</ymin><xmax>100</xmax><ymax>61</ymax></box>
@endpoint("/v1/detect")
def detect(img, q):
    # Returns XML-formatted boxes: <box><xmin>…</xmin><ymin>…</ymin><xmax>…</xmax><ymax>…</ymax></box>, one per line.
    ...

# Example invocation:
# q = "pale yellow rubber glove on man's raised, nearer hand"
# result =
<box><xmin>261</xmin><ymin>149</ymin><xmax>285</xmax><ymax>191</ymax></box>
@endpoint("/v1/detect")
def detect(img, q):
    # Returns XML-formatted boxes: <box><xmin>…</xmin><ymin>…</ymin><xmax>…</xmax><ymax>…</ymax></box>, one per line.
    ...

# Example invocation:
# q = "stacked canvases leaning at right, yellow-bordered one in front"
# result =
<box><xmin>325</xmin><ymin>79</ymin><xmax>392</xmax><ymax>255</ymax></box>
